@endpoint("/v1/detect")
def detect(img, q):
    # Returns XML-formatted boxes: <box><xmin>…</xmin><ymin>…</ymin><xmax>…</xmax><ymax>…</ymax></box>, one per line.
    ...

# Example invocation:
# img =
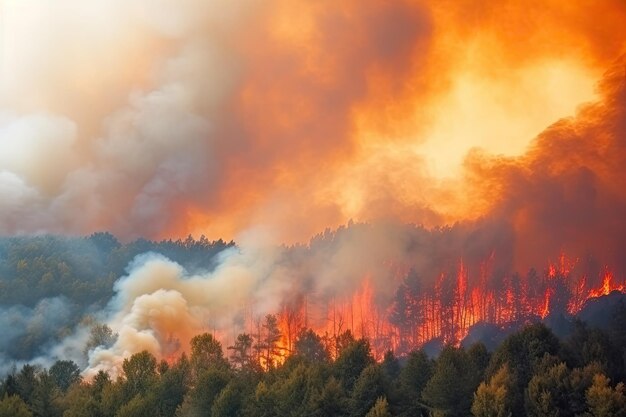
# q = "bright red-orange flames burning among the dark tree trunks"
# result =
<box><xmin>260</xmin><ymin>250</ymin><xmax>626</xmax><ymax>360</ymax></box>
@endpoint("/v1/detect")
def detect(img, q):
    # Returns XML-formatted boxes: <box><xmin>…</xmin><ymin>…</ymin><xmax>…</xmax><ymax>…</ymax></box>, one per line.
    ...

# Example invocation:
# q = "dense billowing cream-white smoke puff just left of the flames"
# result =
<box><xmin>86</xmin><ymin>245</ymin><xmax>279</xmax><ymax>375</ymax></box>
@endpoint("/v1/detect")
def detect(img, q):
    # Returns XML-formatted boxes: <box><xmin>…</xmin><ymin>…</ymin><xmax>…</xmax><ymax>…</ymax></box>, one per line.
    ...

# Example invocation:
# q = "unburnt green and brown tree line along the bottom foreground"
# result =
<box><xmin>0</xmin><ymin>303</ymin><xmax>626</xmax><ymax>417</ymax></box>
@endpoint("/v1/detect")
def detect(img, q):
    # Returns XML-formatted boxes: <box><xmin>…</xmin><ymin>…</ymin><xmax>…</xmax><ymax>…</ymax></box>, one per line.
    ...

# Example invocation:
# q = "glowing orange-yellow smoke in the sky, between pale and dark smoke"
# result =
<box><xmin>173</xmin><ymin>1</ymin><xmax>626</xmax><ymax>241</ymax></box>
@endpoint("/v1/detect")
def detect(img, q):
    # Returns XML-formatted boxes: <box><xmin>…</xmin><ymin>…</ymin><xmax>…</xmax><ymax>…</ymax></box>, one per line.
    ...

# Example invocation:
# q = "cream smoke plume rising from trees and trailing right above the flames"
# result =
<box><xmin>79</xmin><ymin>224</ymin><xmax>426</xmax><ymax>376</ymax></box>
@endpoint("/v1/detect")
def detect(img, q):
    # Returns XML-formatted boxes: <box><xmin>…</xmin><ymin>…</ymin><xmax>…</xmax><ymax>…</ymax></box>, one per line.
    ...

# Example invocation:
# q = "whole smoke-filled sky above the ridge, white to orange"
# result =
<box><xmin>0</xmin><ymin>0</ymin><xmax>626</xmax><ymax>242</ymax></box>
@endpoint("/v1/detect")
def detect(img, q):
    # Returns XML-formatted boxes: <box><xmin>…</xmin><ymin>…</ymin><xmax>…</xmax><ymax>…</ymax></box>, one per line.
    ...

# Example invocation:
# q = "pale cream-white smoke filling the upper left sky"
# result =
<box><xmin>0</xmin><ymin>0</ymin><xmax>251</xmax><ymax>237</ymax></box>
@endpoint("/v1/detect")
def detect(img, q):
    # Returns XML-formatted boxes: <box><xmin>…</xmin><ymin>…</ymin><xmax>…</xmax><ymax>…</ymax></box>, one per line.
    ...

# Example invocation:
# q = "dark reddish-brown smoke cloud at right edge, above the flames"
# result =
<box><xmin>466</xmin><ymin>58</ymin><xmax>626</xmax><ymax>271</ymax></box>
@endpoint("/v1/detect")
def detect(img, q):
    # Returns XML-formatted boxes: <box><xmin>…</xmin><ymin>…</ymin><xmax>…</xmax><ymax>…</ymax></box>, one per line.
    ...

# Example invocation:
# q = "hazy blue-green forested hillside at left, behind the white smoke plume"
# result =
<box><xmin>0</xmin><ymin>233</ymin><xmax>234</xmax><ymax>364</ymax></box>
